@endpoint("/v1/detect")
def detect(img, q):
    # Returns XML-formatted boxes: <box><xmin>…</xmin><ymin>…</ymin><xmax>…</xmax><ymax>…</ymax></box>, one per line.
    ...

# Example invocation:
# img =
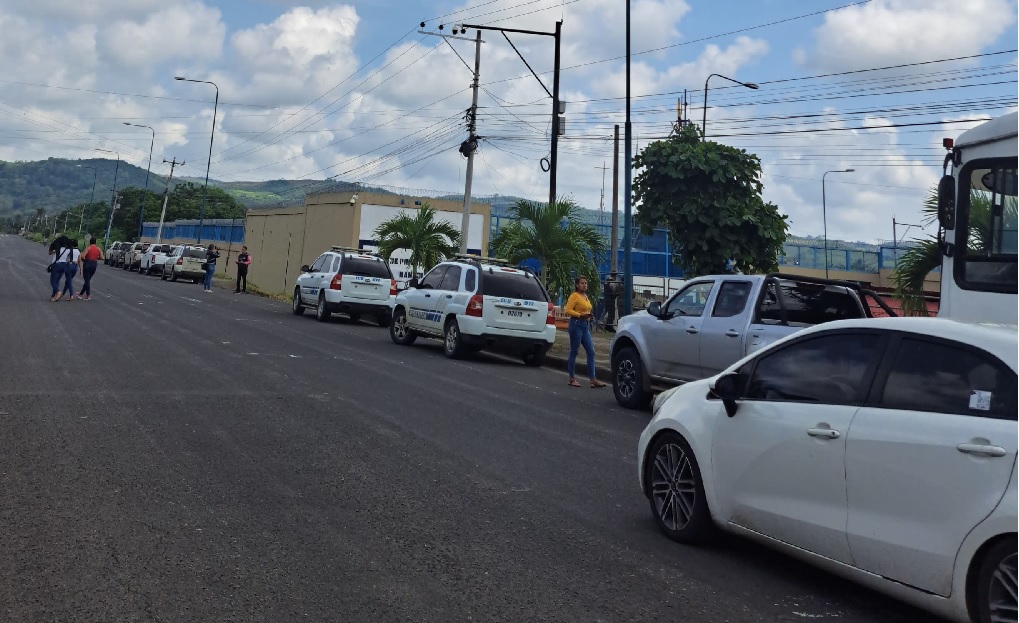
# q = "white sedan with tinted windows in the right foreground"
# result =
<box><xmin>638</xmin><ymin>318</ymin><xmax>1019</xmax><ymax>623</ymax></box>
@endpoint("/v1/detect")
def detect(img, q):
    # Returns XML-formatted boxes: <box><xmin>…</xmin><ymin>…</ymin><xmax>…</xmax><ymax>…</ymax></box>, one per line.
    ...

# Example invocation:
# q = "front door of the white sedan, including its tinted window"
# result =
<box><xmin>711</xmin><ymin>330</ymin><xmax>884</xmax><ymax>563</ymax></box>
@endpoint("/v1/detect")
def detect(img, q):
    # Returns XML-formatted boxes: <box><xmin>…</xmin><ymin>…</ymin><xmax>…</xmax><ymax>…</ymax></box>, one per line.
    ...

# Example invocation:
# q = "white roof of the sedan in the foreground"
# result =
<box><xmin>790</xmin><ymin>317</ymin><xmax>1019</xmax><ymax>371</ymax></box>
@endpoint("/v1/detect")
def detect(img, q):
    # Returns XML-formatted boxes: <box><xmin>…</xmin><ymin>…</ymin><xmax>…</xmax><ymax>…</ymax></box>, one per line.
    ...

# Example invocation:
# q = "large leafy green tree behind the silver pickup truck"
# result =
<box><xmin>634</xmin><ymin>125</ymin><xmax>789</xmax><ymax>276</ymax></box>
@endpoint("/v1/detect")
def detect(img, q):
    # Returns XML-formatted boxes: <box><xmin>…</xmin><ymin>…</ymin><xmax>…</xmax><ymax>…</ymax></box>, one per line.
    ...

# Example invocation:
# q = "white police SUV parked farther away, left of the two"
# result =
<box><xmin>293</xmin><ymin>247</ymin><xmax>396</xmax><ymax>326</ymax></box>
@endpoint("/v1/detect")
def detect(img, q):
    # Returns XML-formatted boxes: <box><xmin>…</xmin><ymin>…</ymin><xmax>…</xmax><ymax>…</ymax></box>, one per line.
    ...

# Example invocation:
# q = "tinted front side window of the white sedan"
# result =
<box><xmin>744</xmin><ymin>332</ymin><xmax>880</xmax><ymax>405</ymax></box>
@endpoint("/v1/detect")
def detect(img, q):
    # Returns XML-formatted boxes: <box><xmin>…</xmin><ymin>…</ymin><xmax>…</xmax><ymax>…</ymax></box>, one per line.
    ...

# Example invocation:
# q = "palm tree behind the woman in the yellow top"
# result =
<box><xmin>491</xmin><ymin>199</ymin><xmax>606</xmax><ymax>298</ymax></box>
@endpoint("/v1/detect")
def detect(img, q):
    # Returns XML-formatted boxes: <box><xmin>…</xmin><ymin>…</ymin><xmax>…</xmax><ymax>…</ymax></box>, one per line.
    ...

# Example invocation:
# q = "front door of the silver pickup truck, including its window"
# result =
<box><xmin>647</xmin><ymin>280</ymin><xmax>715</xmax><ymax>380</ymax></box>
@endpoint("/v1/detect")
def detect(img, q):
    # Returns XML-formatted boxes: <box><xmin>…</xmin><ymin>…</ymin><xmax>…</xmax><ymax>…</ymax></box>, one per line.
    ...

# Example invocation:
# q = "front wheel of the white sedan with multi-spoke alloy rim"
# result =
<box><xmin>644</xmin><ymin>432</ymin><xmax>715</xmax><ymax>543</ymax></box>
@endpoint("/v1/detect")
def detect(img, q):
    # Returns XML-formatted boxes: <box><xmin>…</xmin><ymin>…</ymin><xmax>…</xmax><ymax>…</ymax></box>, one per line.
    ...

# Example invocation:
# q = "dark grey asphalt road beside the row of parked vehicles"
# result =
<box><xmin>0</xmin><ymin>236</ymin><xmax>928</xmax><ymax>623</ymax></box>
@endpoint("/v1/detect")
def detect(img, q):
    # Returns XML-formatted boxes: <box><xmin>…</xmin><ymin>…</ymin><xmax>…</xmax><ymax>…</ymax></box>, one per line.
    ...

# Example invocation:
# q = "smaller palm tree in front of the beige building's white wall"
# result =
<box><xmin>375</xmin><ymin>203</ymin><xmax>461</xmax><ymax>276</ymax></box>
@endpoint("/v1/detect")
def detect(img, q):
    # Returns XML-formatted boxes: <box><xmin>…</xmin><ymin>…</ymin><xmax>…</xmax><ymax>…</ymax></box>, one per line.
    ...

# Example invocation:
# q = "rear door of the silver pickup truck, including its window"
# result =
<box><xmin>700</xmin><ymin>279</ymin><xmax>753</xmax><ymax>377</ymax></box>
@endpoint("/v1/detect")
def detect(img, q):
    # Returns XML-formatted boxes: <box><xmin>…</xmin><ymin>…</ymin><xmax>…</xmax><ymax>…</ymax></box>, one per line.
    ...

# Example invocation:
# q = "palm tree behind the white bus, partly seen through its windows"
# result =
<box><xmin>892</xmin><ymin>187</ymin><xmax>1016</xmax><ymax>316</ymax></box>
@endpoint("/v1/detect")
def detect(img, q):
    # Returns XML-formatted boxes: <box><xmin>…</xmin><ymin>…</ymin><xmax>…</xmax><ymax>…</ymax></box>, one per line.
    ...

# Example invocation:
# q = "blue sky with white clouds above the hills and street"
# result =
<box><xmin>0</xmin><ymin>0</ymin><xmax>1019</xmax><ymax>243</ymax></box>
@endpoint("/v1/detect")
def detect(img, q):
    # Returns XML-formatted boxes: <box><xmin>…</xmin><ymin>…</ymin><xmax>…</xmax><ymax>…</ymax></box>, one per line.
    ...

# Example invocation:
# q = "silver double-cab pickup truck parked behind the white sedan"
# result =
<box><xmin>609</xmin><ymin>273</ymin><xmax>895</xmax><ymax>409</ymax></box>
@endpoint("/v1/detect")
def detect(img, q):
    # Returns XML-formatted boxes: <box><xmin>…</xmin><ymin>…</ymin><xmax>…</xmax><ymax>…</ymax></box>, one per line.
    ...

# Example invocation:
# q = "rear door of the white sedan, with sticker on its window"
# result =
<box><xmin>846</xmin><ymin>335</ymin><xmax>1017</xmax><ymax>596</ymax></box>
